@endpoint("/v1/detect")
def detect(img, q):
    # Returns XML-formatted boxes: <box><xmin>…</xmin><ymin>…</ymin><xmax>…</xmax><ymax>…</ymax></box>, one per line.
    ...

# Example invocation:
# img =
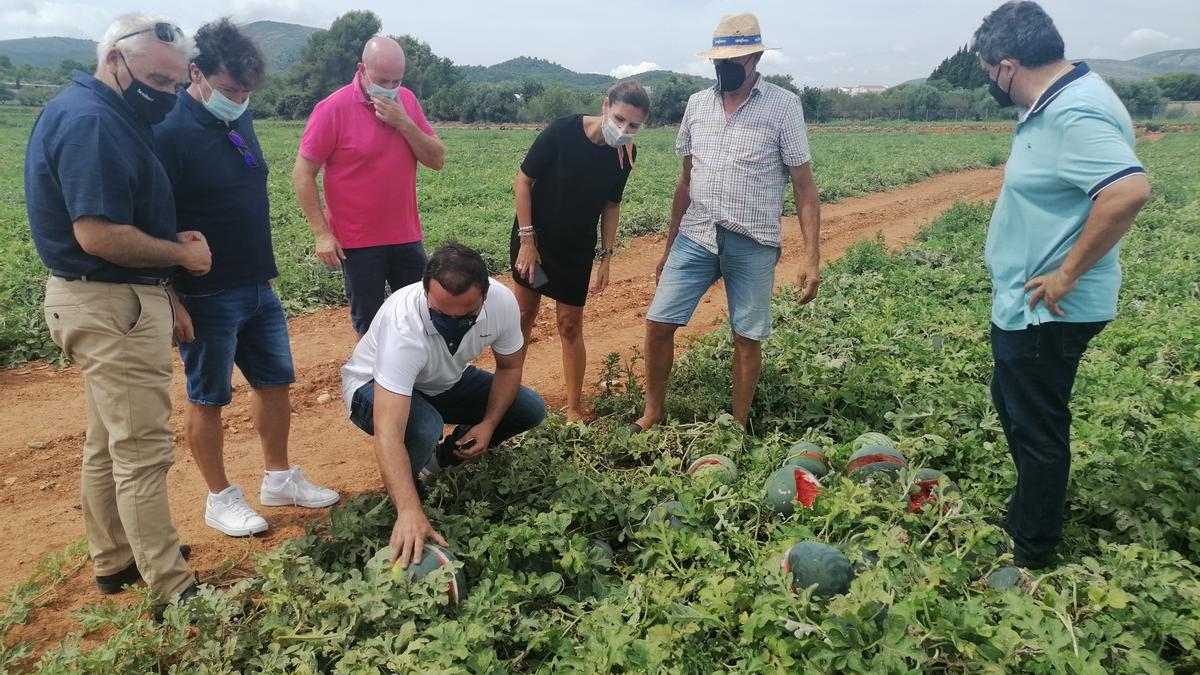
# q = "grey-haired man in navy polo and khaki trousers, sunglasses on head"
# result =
<box><xmin>25</xmin><ymin>14</ymin><xmax>211</xmax><ymax>616</ymax></box>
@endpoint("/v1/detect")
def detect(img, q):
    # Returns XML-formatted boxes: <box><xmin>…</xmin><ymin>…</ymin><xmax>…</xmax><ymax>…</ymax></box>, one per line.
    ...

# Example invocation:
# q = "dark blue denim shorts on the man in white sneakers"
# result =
<box><xmin>179</xmin><ymin>281</ymin><xmax>295</xmax><ymax>406</ymax></box>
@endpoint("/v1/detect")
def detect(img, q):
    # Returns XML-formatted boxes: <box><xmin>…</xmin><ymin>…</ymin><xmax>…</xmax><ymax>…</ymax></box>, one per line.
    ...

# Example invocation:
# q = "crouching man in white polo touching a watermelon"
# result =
<box><xmin>342</xmin><ymin>244</ymin><xmax>546</xmax><ymax>567</ymax></box>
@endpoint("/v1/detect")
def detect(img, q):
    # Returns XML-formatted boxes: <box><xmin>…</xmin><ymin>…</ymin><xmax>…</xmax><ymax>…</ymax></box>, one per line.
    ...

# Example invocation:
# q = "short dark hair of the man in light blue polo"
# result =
<box><xmin>971</xmin><ymin>0</ymin><xmax>1064</xmax><ymax>68</ymax></box>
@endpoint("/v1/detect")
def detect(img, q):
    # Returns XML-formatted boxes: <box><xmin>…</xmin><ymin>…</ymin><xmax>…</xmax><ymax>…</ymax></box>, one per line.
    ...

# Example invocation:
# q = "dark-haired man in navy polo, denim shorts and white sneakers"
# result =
<box><xmin>155</xmin><ymin>19</ymin><xmax>338</xmax><ymax>537</ymax></box>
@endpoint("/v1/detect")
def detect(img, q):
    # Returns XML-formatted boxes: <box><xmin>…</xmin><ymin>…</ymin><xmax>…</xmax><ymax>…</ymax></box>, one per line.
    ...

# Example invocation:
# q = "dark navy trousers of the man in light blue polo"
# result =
<box><xmin>991</xmin><ymin>321</ymin><xmax>1106</xmax><ymax>567</ymax></box>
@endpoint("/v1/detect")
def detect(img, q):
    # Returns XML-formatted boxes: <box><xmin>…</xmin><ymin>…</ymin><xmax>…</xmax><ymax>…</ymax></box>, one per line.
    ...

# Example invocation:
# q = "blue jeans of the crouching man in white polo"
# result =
<box><xmin>350</xmin><ymin>365</ymin><xmax>546</xmax><ymax>473</ymax></box>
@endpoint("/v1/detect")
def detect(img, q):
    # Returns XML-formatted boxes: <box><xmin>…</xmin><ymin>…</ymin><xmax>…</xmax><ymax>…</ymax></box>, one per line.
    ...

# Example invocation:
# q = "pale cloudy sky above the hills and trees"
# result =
<box><xmin>0</xmin><ymin>0</ymin><xmax>1200</xmax><ymax>85</ymax></box>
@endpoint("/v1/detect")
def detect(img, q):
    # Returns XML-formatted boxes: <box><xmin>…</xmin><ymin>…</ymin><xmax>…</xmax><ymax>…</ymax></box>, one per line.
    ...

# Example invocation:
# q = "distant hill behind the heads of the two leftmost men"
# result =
<box><xmin>0</xmin><ymin>22</ymin><xmax>319</xmax><ymax>73</ymax></box>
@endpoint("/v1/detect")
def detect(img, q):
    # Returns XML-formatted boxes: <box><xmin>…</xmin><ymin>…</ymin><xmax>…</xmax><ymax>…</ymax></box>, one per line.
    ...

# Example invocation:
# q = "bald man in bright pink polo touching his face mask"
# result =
<box><xmin>292</xmin><ymin>37</ymin><xmax>445</xmax><ymax>338</ymax></box>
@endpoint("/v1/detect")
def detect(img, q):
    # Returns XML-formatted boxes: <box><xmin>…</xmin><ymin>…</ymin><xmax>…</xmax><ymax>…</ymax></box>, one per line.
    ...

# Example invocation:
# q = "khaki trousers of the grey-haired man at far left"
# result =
<box><xmin>44</xmin><ymin>276</ymin><xmax>194</xmax><ymax>599</ymax></box>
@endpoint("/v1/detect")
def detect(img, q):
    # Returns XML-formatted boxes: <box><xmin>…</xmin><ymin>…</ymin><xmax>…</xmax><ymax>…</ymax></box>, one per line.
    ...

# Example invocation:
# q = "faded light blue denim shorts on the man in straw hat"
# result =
<box><xmin>646</xmin><ymin>227</ymin><xmax>780</xmax><ymax>341</ymax></box>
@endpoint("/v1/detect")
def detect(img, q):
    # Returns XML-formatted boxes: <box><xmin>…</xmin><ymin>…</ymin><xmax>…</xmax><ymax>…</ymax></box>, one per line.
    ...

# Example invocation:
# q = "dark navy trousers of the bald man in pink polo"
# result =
<box><xmin>342</xmin><ymin>241</ymin><xmax>425</xmax><ymax>334</ymax></box>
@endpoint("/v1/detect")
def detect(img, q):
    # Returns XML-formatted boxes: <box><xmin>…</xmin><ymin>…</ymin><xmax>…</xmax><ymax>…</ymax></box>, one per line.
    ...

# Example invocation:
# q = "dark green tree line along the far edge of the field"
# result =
<box><xmin>0</xmin><ymin>16</ymin><xmax>1200</xmax><ymax>125</ymax></box>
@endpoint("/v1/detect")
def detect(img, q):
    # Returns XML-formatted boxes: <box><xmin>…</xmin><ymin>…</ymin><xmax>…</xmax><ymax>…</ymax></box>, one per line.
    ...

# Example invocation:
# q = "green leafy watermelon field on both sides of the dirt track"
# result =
<box><xmin>0</xmin><ymin>128</ymin><xmax>1200</xmax><ymax>674</ymax></box>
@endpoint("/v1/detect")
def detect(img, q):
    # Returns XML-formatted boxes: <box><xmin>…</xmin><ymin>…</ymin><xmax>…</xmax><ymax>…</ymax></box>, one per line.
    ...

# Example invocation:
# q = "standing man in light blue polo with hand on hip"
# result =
<box><xmin>972</xmin><ymin>1</ymin><xmax>1150</xmax><ymax>568</ymax></box>
